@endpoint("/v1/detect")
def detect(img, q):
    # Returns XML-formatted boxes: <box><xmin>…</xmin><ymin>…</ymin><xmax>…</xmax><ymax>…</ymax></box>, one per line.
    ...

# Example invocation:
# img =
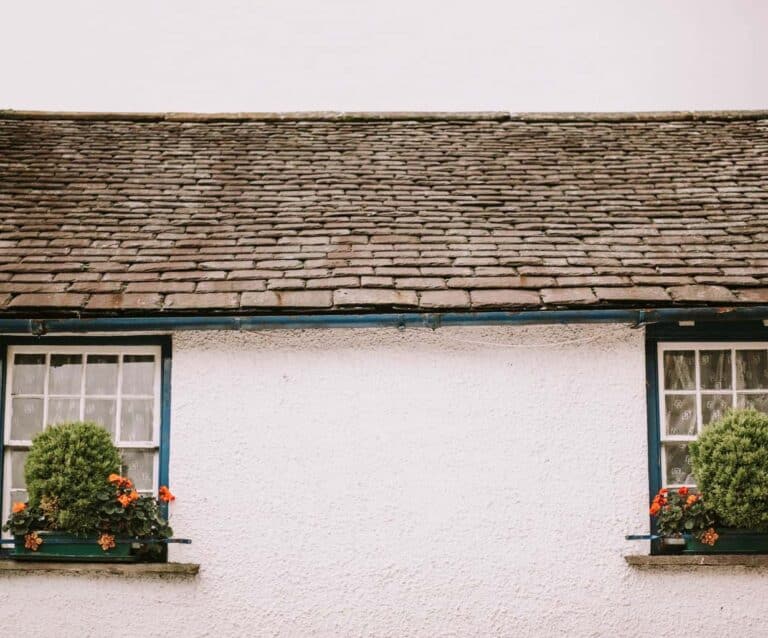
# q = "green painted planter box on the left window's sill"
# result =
<box><xmin>12</xmin><ymin>532</ymin><xmax>165</xmax><ymax>563</ymax></box>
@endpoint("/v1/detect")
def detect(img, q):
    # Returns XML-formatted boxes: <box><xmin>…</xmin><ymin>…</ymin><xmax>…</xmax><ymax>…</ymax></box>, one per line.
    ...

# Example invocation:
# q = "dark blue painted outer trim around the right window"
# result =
<box><xmin>645</xmin><ymin>321</ymin><xmax>768</xmax><ymax>554</ymax></box>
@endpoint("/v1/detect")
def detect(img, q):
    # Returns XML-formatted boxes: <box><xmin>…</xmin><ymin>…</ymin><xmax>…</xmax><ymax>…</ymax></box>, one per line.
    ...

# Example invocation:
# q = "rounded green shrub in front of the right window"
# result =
<box><xmin>690</xmin><ymin>410</ymin><xmax>768</xmax><ymax>530</ymax></box>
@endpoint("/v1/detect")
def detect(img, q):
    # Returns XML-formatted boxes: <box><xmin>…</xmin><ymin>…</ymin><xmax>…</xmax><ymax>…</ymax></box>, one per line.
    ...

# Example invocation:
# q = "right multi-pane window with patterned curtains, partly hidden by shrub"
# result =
<box><xmin>658</xmin><ymin>342</ymin><xmax>768</xmax><ymax>487</ymax></box>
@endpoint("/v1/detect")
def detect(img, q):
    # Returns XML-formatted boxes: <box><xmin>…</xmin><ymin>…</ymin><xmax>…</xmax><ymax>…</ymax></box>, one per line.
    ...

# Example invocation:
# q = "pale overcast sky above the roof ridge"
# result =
<box><xmin>0</xmin><ymin>0</ymin><xmax>768</xmax><ymax>111</ymax></box>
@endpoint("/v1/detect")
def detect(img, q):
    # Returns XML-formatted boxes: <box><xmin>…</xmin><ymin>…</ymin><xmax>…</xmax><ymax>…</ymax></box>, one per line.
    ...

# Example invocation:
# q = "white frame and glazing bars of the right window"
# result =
<box><xmin>657</xmin><ymin>341</ymin><xmax>768</xmax><ymax>488</ymax></box>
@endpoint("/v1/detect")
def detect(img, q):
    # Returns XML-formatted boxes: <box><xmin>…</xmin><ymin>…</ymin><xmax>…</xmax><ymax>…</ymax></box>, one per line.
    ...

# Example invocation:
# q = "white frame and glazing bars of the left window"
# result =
<box><xmin>2</xmin><ymin>344</ymin><xmax>162</xmax><ymax>537</ymax></box>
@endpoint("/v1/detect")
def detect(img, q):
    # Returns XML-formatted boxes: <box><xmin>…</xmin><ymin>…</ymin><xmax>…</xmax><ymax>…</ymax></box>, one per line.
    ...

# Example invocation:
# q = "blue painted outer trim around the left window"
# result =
<box><xmin>0</xmin><ymin>336</ymin><xmax>172</xmax><ymax>552</ymax></box>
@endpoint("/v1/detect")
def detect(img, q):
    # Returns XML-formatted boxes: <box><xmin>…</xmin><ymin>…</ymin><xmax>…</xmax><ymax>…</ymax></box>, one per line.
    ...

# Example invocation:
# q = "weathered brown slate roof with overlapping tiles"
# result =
<box><xmin>0</xmin><ymin>112</ymin><xmax>768</xmax><ymax>316</ymax></box>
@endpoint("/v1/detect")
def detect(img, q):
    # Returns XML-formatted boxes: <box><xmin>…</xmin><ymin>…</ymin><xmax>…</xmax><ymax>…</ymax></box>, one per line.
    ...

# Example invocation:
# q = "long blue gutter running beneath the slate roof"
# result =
<box><xmin>0</xmin><ymin>306</ymin><xmax>768</xmax><ymax>335</ymax></box>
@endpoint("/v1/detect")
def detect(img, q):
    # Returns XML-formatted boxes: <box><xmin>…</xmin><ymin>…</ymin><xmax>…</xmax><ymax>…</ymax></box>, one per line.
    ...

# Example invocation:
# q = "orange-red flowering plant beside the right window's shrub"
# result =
<box><xmin>649</xmin><ymin>487</ymin><xmax>718</xmax><ymax>545</ymax></box>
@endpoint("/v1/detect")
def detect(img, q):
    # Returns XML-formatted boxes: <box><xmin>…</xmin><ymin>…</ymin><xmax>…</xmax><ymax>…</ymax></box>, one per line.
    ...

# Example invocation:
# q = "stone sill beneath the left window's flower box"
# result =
<box><xmin>0</xmin><ymin>560</ymin><xmax>200</xmax><ymax>578</ymax></box>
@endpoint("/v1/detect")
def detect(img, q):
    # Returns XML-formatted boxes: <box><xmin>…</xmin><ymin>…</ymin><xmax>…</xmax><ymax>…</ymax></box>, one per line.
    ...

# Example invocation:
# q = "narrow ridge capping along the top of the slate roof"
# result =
<box><xmin>0</xmin><ymin>109</ymin><xmax>768</xmax><ymax>122</ymax></box>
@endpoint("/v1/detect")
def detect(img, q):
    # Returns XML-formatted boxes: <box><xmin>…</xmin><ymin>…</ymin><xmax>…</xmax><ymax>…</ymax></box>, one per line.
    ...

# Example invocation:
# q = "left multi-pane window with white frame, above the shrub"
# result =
<box><xmin>2</xmin><ymin>344</ymin><xmax>167</xmax><ymax>536</ymax></box>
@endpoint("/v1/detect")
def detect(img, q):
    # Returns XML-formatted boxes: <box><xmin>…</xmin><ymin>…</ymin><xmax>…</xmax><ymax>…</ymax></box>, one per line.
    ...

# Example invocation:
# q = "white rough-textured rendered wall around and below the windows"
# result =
<box><xmin>0</xmin><ymin>326</ymin><xmax>768</xmax><ymax>638</ymax></box>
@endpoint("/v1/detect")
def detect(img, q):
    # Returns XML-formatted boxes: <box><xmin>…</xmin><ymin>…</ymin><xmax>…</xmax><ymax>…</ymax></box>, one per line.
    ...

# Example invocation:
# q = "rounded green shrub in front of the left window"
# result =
<box><xmin>24</xmin><ymin>422</ymin><xmax>120</xmax><ymax>534</ymax></box>
